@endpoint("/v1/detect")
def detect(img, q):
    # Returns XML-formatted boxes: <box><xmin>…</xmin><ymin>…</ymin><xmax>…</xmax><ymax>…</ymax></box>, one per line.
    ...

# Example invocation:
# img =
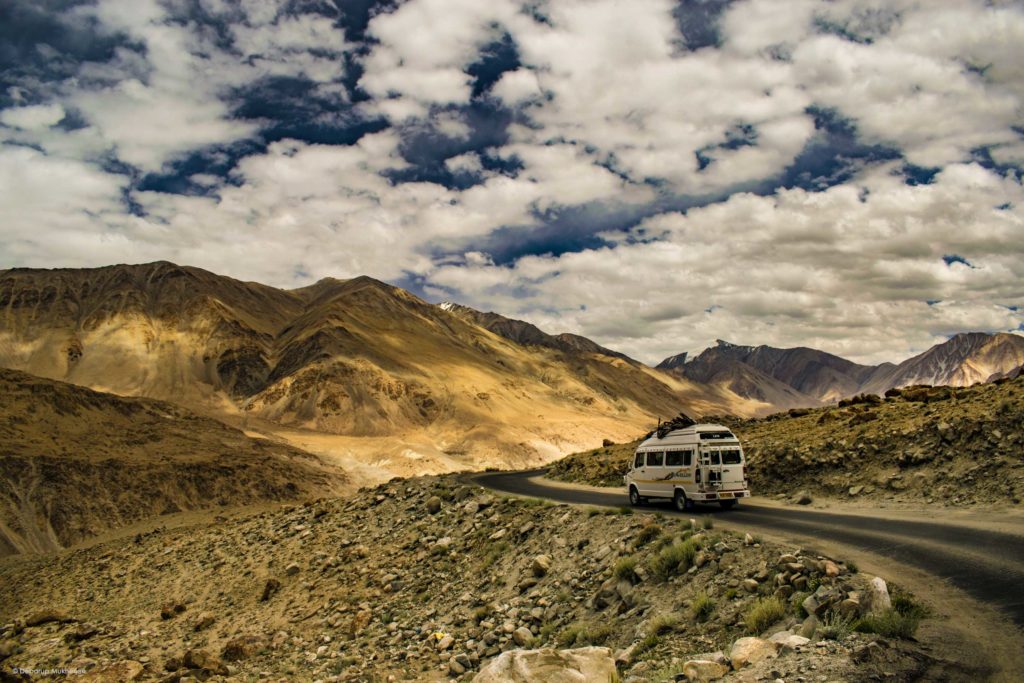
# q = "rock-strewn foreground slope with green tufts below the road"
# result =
<box><xmin>0</xmin><ymin>476</ymin><xmax>981</xmax><ymax>683</ymax></box>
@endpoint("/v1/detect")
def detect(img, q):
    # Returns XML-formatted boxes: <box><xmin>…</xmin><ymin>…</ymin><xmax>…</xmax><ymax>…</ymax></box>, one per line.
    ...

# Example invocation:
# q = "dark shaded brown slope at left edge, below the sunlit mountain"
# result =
<box><xmin>0</xmin><ymin>369</ymin><xmax>349</xmax><ymax>555</ymax></box>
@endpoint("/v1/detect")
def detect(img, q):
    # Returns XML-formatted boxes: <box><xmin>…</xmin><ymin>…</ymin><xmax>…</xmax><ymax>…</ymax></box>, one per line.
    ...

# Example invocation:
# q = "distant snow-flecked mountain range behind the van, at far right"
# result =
<box><xmin>656</xmin><ymin>332</ymin><xmax>1024</xmax><ymax>409</ymax></box>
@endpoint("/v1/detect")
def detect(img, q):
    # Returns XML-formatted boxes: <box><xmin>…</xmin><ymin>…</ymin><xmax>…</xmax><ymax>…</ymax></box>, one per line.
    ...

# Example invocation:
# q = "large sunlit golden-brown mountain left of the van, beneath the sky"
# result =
<box><xmin>0</xmin><ymin>263</ymin><xmax>766</xmax><ymax>481</ymax></box>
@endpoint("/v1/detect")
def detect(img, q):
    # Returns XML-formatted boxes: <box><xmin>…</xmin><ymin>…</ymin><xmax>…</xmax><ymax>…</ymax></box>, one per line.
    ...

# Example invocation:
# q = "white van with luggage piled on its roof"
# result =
<box><xmin>624</xmin><ymin>425</ymin><xmax>751</xmax><ymax>510</ymax></box>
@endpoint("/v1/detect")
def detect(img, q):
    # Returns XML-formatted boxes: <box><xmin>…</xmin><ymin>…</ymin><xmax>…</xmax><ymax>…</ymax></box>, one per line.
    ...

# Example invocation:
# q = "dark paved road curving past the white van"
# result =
<box><xmin>472</xmin><ymin>470</ymin><xmax>1024</xmax><ymax>626</ymax></box>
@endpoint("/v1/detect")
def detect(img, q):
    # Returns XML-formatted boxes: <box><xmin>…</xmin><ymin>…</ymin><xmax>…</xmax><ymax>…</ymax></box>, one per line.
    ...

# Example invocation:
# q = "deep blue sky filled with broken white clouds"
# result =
<box><xmin>0</xmin><ymin>0</ymin><xmax>1024</xmax><ymax>364</ymax></box>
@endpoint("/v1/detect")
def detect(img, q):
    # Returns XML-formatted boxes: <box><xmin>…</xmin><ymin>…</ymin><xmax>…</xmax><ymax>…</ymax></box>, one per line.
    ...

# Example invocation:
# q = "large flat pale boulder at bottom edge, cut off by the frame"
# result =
<box><xmin>473</xmin><ymin>647</ymin><xmax>615</xmax><ymax>683</ymax></box>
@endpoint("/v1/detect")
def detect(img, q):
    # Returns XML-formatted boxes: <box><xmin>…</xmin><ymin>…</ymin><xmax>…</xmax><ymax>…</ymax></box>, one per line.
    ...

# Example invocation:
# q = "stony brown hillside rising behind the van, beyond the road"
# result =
<box><xmin>550</xmin><ymin>377</ymin><xmax>1024</xmax><ymax>505</ymax></box>
